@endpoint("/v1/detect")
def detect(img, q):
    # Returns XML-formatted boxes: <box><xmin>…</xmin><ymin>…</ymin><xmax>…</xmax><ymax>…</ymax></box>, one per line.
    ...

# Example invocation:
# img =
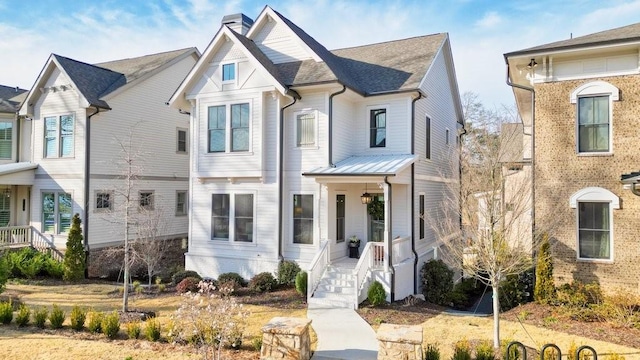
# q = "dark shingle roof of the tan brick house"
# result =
<box><xmin>505</xmin><ymin>23</ymin><xmax>640</xmax><ymax>57</ymax></box>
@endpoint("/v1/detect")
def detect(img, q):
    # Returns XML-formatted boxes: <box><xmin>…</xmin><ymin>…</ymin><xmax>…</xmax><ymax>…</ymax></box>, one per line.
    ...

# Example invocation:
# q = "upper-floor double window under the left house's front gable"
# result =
<box><xmin>44</xmin><ymin>115</ymin><xmax>74</xmax><ymax>158</ymax></box>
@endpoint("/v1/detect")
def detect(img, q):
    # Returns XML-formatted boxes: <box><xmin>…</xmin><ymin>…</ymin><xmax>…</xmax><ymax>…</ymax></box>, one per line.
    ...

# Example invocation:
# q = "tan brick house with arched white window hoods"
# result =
<box><xmin>504</xmin><ymin>23</ymin><xmax>640</xmax><ymax>291</ymax></box>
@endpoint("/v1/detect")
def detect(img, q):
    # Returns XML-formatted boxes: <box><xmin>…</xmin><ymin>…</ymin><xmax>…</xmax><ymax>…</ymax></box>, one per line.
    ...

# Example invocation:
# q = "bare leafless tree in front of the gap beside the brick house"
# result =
<box><xmin>430</xmin><ymin>93</ymin><xmax>536</xmax><ymax>348</ymax></box>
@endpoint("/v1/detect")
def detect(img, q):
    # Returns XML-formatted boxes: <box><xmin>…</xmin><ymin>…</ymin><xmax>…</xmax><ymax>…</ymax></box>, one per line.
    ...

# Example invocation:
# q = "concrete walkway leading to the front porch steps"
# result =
<box><xmin>307</xmin><ymin>309</ymin><xmax>378</xmax><ymax>360</ymax></box>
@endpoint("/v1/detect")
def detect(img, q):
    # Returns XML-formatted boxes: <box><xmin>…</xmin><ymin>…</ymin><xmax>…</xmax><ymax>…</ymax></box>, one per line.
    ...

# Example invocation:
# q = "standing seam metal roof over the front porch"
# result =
<box><xmin>302</xmin><ymin>154</ymin><xmax>417</xmax><ymax>177</ymax></box>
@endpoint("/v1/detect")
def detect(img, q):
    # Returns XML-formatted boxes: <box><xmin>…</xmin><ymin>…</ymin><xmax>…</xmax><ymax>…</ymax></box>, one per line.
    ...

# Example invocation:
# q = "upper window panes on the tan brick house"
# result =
<box><xmin>578</xmin><ymin>96</ymin><xmax>609</xmax><ymax>152</ymax></box>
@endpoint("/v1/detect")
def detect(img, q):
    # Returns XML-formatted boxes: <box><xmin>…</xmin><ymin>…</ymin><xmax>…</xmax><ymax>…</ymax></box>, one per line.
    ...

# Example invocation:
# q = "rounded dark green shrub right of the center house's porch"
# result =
<box><xmin>420</xmin><ymin>260</ymin><xmax>453</xmax><ymax>305</ymax></box>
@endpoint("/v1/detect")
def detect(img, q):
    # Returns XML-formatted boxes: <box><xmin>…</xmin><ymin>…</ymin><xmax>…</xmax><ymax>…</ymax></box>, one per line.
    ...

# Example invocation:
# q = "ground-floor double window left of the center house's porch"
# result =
<box><xmin>211</xmin><ymin>194</ymin><xmax>254</xmax><ymax>242</ymax></box>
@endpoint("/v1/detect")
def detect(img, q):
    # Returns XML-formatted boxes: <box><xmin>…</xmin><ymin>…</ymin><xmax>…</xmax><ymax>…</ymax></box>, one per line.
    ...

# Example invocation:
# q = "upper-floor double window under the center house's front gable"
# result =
<box><xmin>207</xmin><ymin>103</ymin><xmax>251</xmax><ymax>153</ymax></box>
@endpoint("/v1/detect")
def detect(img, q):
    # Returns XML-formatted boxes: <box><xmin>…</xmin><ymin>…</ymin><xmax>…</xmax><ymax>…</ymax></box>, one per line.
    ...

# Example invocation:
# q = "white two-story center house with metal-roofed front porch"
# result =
<box><xmin>170</xmin><ymin>6</ymin><xmax>463</xmax><ymax>305</ymax></box>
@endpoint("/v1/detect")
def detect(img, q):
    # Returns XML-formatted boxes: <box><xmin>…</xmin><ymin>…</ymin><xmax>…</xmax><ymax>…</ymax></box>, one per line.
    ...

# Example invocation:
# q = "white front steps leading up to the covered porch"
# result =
<box><xmin>307</xmin><ymin>265</ymin><xmax>356</xmax><ymax>309</ymax></box>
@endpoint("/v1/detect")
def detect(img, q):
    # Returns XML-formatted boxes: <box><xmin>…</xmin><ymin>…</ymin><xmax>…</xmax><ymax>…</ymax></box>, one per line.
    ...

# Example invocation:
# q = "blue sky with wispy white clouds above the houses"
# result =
<box><xmin>0</xmin><ymin>0</ymin><xmax>640</xmax><ymax>107</ymax></box>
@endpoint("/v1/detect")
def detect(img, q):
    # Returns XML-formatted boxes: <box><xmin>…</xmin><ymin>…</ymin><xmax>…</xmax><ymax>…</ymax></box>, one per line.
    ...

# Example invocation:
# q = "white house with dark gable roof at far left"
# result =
<box><xmin>11</xmin><ymin>48</ymin><xmax>199</xmax><ymax>258</ymax></box>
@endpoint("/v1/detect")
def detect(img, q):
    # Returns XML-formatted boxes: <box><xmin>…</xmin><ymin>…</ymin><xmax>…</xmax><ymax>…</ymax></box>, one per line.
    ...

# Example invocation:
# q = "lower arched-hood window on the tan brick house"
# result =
<box><xmin>569</xmin><ymin>187</ymin><xmax>620</xmax><ymax>261</ymax></box>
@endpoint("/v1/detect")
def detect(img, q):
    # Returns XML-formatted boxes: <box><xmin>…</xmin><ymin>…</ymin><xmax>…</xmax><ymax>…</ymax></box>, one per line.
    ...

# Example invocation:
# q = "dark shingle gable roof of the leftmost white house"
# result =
<box><xmin>27</xmin><ymin>48</ymin><xmax>197</xmax><ymax>113</ymax></box>
